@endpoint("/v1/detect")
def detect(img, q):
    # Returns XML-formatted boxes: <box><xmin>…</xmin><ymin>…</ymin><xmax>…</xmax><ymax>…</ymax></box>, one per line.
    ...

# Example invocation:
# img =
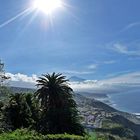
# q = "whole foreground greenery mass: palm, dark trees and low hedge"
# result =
<box><xmin>0</xmin><ymin>73</ymin><xmax>85</xmax><ymax>140</ymax></box>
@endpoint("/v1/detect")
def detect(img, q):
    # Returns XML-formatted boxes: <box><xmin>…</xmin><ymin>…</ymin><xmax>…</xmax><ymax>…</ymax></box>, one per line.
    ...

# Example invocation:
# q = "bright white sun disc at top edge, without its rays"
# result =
<box><xmin>33</xmin><ymin>0</ymin><xmax>62</xmax><ymax>14</ymax></box>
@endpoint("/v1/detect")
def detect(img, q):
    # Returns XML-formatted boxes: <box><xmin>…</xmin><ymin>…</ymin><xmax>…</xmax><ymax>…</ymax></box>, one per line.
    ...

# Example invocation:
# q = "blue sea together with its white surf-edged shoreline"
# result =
<box><xmin>93</xmin><ymin>93</ymin><xmax>140</xmax><ymax>114</ymax></box>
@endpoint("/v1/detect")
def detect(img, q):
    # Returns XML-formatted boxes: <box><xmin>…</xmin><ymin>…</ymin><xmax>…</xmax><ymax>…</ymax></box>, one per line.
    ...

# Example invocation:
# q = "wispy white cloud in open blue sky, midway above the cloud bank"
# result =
<box><xmin>113</xmin><ymin>43</ymin><xmax>140</xmax><ymax>56</ymax></box>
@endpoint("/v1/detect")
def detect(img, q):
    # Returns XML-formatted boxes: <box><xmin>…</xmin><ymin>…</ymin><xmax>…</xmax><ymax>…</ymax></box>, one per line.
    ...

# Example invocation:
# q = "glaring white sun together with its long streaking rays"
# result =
<box><xmin>0</xmin><ymin>0</ymin><xmax>70</xmax><ymax>31</ymax></box>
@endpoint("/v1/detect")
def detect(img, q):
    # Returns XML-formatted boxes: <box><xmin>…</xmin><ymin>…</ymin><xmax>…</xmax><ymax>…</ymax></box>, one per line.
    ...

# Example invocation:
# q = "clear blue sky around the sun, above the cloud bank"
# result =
<box><xmin>0</xmin><ymin>0</ymin><xmax>140</xmax><ymax>80</ymax></box>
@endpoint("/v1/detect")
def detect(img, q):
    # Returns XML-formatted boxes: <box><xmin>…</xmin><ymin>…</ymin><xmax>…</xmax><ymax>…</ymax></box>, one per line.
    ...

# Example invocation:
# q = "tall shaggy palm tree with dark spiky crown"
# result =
<box><xmin>36</xmin><ymin>73</ymin><xmax>84</xmax><ymax>135</ymax></box>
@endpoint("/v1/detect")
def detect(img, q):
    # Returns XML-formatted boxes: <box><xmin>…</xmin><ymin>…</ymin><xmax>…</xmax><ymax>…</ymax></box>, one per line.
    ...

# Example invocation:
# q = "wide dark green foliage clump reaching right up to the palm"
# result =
<box><xmin>3</xmin><ymin>93</ymin><xmax>39</xmax><ymax>130</ymax></box>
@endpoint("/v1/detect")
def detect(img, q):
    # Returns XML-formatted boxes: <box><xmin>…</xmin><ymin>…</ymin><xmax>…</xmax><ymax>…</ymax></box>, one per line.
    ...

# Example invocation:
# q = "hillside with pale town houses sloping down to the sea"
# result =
<box><xmin>75</xmin><ymin>94</ymin><xmax>140</xmax><ymax>140</ymax></box>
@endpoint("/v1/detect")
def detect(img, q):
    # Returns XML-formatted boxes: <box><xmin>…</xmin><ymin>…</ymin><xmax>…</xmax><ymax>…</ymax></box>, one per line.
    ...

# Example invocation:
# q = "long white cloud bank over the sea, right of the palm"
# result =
<box><xmin>71</xmin><ymin>72</ymin><xmax>140</xmax><ymax>94</ymax></box>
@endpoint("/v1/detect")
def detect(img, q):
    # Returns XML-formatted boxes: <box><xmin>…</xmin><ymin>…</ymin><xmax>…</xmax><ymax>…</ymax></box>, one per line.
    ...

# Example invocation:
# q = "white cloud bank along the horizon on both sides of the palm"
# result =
<box><xmin>6</xmin><ymin>72</ymin><xmax>140</xmax><ymax>94</ymax></box>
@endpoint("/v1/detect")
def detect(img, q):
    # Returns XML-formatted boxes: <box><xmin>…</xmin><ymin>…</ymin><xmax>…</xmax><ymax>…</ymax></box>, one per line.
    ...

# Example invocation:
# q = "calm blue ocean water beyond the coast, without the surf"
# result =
<box><xmin>108</xmin><ymin>92</ymin><xmax>140</xmax><ymax>113</ymax></box>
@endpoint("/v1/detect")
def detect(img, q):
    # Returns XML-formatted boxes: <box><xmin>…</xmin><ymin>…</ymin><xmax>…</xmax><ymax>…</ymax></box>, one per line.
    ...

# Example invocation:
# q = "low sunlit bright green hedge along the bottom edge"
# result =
<box><xmin>0</xmin><ymin>129</ymin><xmax>87</xmax><ymax>140</ymax></box>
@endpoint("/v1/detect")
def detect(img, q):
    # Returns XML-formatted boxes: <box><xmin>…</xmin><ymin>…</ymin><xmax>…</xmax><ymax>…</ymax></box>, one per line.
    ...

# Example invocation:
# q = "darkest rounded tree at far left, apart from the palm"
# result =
<box><xmin>4</xmin><ymin>93</ymin><xmax>33</xmax><ymax>130</ymax></box>
